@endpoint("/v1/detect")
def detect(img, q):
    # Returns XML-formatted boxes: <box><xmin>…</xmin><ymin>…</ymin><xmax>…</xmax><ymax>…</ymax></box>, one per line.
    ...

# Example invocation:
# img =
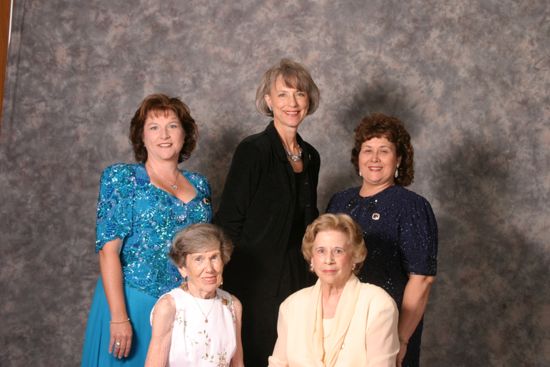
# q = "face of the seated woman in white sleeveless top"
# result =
<box><xmin>179</xmin><ymin>247</ymin><xmax>223</xmax><ymax>298</ymax></box>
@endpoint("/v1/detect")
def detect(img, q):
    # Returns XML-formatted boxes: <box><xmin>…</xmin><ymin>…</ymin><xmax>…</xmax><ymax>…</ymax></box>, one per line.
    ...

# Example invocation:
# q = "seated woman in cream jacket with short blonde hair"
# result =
<box><xmin>269</xmin><ymin>214</ymin><xmax>399</xmax><ymax>367</ymax></box>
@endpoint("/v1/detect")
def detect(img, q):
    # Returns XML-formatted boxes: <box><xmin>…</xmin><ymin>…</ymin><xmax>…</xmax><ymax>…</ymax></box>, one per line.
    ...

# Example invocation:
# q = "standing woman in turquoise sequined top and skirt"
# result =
<box><xmin>82</xmin><ymin>94</ymin><xmax>212</xmax><ymax>367</ymax></box>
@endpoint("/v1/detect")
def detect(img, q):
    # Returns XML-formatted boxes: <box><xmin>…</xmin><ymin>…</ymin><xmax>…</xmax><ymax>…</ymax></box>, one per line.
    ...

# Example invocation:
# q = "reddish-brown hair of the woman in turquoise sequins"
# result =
<box><xmin>130</xmin><ymin>94</ymin><xmax>198</xmax><ymax>163</ymax></box>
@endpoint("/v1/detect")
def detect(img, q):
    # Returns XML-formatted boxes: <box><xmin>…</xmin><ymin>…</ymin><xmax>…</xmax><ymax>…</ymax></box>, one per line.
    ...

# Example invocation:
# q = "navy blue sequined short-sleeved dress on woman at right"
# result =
<box><xmin>327</xmin><ymin>185</ymin><xmax>437</xmax><ymax>366</ymax></box>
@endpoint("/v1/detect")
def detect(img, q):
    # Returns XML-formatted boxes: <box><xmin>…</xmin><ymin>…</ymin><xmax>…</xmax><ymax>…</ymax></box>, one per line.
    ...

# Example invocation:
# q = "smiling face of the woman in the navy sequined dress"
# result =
<box><xmin>358</xmin><ymin>137</ymin><xmax>401</xmax><ymax>191</ymax></box>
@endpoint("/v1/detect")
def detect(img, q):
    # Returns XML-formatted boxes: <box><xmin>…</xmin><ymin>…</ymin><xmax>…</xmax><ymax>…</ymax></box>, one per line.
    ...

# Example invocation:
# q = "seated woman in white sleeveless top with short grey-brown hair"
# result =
<box><xmin>145</xmin><ymin>223</ymin><xmax>243</xmax><ymax>367</ymax></box>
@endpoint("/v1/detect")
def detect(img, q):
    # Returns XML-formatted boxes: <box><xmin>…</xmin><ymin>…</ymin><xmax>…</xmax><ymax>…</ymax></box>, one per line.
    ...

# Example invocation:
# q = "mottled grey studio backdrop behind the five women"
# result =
<box><xmin>0</xmin><ymin>0</ymin><xmax>550</xmax><ymax>366</ymax></box>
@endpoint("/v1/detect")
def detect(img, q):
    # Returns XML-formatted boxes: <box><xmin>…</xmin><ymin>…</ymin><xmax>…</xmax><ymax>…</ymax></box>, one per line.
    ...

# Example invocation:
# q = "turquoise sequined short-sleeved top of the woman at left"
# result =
<box><xmin>96</xmin><ymin>164</ymin><xmax>212</xmax><ymax>298</ymax></box>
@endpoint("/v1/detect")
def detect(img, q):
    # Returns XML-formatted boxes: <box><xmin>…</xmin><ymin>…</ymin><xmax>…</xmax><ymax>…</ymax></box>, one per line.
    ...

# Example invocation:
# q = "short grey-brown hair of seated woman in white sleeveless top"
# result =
<box><xmin>169</xmin><ymin>223</ymin><xmax>233</xmax><ymax>268</ymax></box>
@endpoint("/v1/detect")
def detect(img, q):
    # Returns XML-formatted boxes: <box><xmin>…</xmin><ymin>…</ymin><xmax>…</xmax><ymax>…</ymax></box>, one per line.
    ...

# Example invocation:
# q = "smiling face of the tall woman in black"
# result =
<box><xmin>264</xmin><ymin>75</ymin><xmax>309</xmax><ymax>129</ymax></box>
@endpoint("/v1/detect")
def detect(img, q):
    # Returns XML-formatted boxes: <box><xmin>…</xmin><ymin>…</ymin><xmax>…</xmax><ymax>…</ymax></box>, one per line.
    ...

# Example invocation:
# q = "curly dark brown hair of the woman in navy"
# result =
<box><xmin>351</xmin><ymin>113</ymin><xmax>414</xmax><ymax>186</ymax></box>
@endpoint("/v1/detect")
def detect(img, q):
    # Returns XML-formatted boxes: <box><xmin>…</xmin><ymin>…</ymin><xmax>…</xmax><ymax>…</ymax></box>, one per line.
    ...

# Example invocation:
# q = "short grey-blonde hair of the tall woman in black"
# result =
<box><xmin>256</xmin><ymin>59</ymin><xmax>320</xmax><ymax>117</ymax></box>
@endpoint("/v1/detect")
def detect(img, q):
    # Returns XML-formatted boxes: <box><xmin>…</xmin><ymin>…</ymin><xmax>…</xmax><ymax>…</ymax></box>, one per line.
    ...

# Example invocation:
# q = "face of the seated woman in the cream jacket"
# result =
<box><xmin>311</xmin><ymin>230</ymin><xmax>353</xmax><ymax>288</ymax></box>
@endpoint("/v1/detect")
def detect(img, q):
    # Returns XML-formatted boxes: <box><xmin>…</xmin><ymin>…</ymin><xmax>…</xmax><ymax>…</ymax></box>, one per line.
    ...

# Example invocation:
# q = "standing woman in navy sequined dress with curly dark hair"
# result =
<box><xmin>327</xmin><ymin>114</ymin><xmax>437</xmax><ymax>366</ymax></box>
